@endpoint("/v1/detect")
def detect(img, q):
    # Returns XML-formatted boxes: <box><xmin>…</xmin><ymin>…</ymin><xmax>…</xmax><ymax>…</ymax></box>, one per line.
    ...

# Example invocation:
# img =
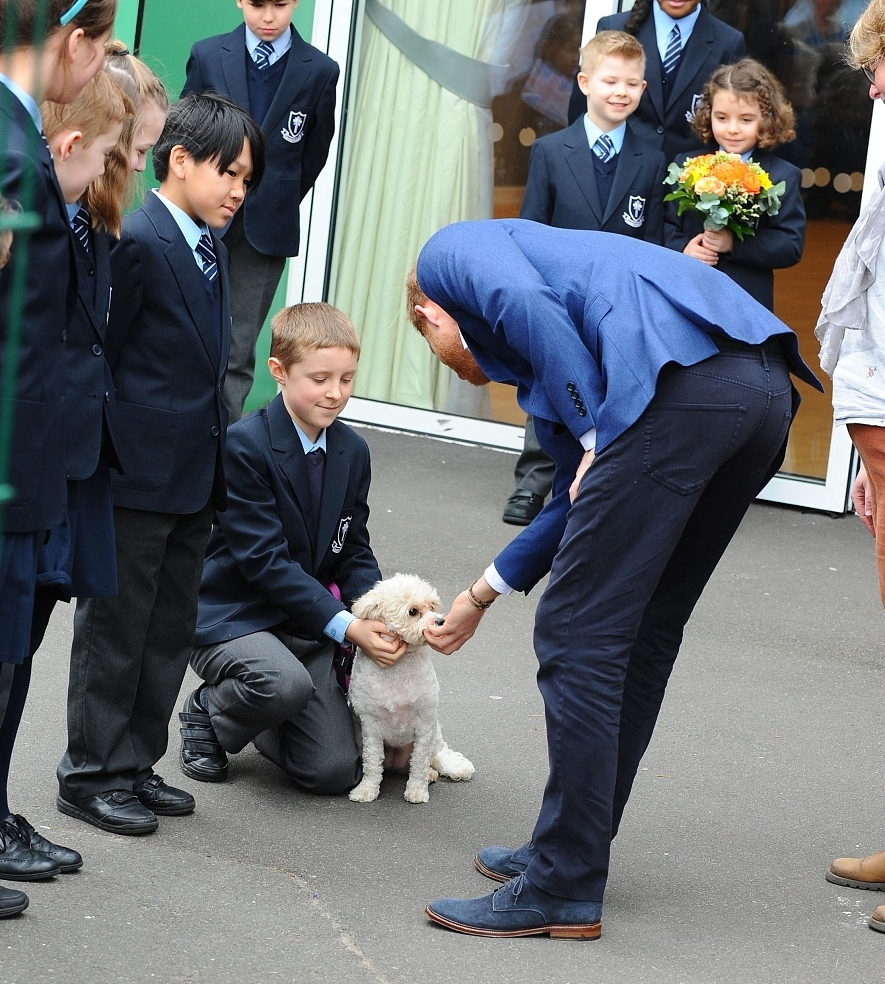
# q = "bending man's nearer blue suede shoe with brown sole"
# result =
<box><xmin>425</xmin><ymin>875</ymin><xmax>602</xmax><ymax>940</ymax></box>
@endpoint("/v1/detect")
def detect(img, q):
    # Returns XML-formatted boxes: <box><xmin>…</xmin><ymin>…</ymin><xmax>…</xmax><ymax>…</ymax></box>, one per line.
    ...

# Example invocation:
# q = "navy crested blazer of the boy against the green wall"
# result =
<box><xmin>181</xmin><ymin>24</ymin><xmax>339</xmax><ymax>256</ymax></box>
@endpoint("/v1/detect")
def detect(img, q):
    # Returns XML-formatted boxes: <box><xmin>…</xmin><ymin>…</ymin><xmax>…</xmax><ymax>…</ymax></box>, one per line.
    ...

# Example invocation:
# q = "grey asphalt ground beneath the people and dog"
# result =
<box><xmin>0</xmin><ymin>430</ymin><xmax>885</xmax><ymax>984</ymax></box>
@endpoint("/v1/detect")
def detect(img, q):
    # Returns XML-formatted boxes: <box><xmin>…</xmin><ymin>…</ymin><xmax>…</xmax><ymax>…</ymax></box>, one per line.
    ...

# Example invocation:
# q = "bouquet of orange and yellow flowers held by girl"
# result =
<box><xmin>664</xmin><ymin>151</ymin><xmax>786</xmax><ymax>242</ymax></box>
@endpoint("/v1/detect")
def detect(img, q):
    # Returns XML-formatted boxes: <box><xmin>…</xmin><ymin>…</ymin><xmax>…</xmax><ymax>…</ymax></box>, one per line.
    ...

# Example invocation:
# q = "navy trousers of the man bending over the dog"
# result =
<box><xmin>527</xmin><ymin>346</ymin><xmax>793</xmax><ymax>901</ymax></box>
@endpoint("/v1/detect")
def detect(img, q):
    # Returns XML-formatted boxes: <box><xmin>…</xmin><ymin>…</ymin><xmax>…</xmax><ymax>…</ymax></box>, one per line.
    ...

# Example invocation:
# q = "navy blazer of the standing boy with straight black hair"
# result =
<box><xmin>106</xmin><ymin>192</ymin><xmax>230</xmax><ymax>515</ymax></box>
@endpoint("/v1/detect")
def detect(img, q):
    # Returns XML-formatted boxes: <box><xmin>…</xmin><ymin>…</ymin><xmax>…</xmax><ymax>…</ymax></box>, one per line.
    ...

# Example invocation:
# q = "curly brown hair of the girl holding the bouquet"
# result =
<box><xmin>692</xmin><ymin>58</ymin><xmax>796</xmax><ymax>150</ymax></box>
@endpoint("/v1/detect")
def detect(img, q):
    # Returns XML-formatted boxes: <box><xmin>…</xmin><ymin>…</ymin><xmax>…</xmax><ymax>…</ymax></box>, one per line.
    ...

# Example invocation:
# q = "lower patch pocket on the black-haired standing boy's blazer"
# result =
<box><xmin>111</xmin><ymin>402</ymin><xmax>178</xmax><ymax>492</ymax></box>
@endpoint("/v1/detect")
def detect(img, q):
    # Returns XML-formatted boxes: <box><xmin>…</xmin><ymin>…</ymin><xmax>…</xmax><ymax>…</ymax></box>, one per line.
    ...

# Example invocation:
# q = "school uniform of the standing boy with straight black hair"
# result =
<box><xmin>58</xmin><ymin>193</ymin><xmax>230</xmax><ymax>804</ymax></box>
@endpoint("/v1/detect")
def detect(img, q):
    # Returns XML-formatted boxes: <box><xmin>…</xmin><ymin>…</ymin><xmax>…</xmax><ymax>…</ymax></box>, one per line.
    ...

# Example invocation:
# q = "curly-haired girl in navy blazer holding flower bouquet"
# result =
<box><xmin>664</xmin><ymin>58</ymin><xmax>805</xmax><ymax>310</ymax></box>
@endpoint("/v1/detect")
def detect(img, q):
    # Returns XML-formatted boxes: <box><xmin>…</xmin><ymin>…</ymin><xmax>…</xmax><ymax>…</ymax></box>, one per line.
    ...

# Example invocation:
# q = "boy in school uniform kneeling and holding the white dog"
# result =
<box><xmin>179</xmin><ymin>303</ymin><xmax>406</xmax><ymax>794</ymax></box>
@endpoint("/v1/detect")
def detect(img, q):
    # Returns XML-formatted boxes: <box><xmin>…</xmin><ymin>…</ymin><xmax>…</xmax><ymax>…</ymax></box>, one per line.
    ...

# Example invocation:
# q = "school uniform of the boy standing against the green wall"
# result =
<box><xmin>181</xmin><ymin>24</ymin><xmax>339</xmax><ymax>421</ymax></box>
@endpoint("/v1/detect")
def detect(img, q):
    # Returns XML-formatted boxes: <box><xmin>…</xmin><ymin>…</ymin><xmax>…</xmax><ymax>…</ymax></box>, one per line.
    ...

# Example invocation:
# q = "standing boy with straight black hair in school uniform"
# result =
<box><xmin>57</xmin><ymin>95</ymin><xmax>264</xmax><ymax>834</ymax></box>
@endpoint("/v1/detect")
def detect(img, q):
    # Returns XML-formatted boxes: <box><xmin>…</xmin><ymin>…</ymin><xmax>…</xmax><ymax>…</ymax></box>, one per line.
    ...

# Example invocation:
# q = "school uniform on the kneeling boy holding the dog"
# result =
<box><xmin>182</xmin><ymin>396</ymin><xmax>381</xmax><ymax>793</ymax></box>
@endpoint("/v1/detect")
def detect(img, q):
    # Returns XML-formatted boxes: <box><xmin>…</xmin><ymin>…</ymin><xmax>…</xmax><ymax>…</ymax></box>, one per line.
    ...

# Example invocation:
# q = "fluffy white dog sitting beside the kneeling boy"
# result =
<box><xmin>348</xmin><ymin>574</ymin><xmax>475</xmax><ymax>803</ymax></box>
